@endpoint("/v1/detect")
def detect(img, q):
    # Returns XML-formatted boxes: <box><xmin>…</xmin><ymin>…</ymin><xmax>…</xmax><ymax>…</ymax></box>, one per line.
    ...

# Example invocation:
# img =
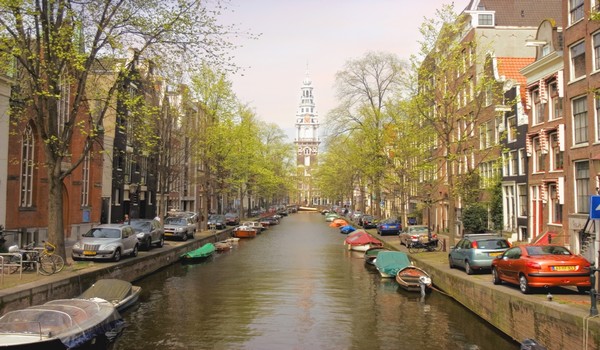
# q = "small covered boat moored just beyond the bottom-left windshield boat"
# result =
<box><xmin>78</xmin><ymin>278</ymin><xmax>142</xmax><ymax>311</ymax></box>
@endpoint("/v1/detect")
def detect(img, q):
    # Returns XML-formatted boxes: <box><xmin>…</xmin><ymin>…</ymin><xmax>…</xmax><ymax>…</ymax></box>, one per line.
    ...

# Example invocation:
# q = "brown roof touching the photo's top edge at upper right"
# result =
<box><xmin>465</xmin><ymin>0</ymin><xmax>562</xmax><ymax>27</ymax></box>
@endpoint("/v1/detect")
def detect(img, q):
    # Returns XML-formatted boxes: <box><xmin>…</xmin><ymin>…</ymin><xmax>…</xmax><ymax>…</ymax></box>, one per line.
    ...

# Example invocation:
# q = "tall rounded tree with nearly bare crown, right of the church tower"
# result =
<box><xmin>328</xmin><ymin>52</ymin><xmax>406</xmax><ymax>215</ymax></box>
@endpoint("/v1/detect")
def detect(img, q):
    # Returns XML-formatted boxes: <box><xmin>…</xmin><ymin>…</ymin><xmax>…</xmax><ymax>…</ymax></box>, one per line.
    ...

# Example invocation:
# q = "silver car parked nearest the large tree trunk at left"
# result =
<box><xmin>71</xmin><ymin>224</ymin><xmax>139</xmax><ymax>261</ymax></box>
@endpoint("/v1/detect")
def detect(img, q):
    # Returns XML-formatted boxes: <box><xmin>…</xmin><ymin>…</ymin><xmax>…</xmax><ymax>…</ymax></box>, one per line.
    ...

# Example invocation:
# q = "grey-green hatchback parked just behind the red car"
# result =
<box><xmin>448</xmin><ymin>234</ymin><xmax>510</xmax><ymax>275</ymax></box>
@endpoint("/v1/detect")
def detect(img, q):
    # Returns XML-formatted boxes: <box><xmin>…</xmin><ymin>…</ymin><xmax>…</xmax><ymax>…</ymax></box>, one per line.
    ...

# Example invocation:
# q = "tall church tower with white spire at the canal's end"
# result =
<box><xmin>294</xmin><ymin>71</ymin><xmax>321</xmax><ymax>206</ymax></box>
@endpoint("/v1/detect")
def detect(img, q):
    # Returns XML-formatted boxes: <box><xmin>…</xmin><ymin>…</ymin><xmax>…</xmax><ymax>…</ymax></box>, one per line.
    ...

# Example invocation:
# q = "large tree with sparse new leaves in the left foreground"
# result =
<box><xmin>0</xmin><ymin>0</ymin><xmax>240</xmax><ymax>257</ymax></box>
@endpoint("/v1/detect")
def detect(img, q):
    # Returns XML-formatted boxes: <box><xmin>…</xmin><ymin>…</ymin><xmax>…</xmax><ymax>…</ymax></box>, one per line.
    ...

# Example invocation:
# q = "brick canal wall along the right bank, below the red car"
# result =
<box><xmin>411</xmin><ymin>254</ymin><xmax>600</xmax><ymax>350</ymax></box>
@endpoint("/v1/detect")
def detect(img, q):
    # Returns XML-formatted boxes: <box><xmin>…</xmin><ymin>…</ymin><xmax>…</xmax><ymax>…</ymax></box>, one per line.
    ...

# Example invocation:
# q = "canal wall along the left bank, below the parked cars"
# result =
<box><xmin>0</xmin><ymin>229</ymin><xmax>232</xmax><ymax>315</ymax></box>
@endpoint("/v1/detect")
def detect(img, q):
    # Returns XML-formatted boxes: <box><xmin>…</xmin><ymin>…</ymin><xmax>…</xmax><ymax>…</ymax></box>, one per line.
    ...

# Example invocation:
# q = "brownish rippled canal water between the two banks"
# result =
<box><xmin>113</xmin><ymin>213</ymin><xmax>519</xmax><ymax>350</ymax></box>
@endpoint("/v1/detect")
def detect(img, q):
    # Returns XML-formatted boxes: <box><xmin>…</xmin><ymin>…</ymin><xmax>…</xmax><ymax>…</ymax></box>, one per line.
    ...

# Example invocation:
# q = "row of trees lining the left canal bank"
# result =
<box><xmin>0</xmin><ymin>0</ymin><xmax>289</xmax><ymax>256</ymax></box>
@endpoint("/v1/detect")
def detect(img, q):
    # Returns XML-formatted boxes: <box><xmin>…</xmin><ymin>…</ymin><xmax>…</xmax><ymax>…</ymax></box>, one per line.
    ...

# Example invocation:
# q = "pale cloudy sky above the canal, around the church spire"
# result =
<box><xmin>222</xmin><ymin>0</ymin><xmax>460</xmax><ymax>141</ymax></box>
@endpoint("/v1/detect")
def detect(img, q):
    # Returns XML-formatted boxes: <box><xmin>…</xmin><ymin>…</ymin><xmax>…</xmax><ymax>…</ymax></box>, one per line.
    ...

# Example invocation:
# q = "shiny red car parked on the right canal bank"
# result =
<box><xmin>492</xmin><ymin>244</ymin><xmax>592</xmax><ymax>294</ymax></box>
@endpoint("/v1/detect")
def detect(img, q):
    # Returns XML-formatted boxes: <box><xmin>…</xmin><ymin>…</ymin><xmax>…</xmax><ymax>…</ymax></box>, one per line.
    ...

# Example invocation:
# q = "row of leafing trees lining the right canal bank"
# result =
<box><xmin>318</xmin><ymin>5</ymin><xmax>502</xmax><ymax>243</ymax></box>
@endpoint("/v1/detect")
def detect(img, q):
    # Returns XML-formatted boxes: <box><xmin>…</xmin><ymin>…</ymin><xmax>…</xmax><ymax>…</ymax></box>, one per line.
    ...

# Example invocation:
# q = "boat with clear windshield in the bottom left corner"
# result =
<box><xmin>0</xmin><ymin>298</ymin><xmax>124</xmax><ymax>350</ymax></box>
